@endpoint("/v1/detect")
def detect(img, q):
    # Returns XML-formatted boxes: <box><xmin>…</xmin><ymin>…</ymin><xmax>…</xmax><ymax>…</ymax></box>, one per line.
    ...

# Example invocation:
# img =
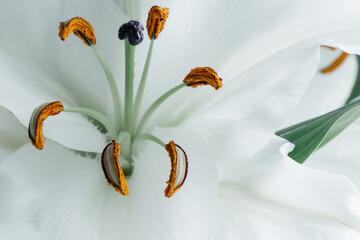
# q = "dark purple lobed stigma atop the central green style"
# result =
<box><xmin>119</xmin><ymin>20</ymin><xmax>144</xmax><ymax>46</ymax></box>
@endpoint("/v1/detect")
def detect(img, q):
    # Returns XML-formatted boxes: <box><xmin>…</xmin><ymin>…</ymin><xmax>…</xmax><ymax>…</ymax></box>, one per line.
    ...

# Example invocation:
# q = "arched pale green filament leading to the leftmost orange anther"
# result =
<box><xmin>63</xmin><ymin>107</ymin><xmax>116</xmax><ymax>138</ymax></box>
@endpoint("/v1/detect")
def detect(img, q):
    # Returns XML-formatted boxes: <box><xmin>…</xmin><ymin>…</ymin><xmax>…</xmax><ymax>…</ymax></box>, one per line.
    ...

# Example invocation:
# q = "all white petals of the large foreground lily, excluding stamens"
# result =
<box><xmin>0</xmin><ymin>0</ymin><xmax>360</xmax><ymax>240</ymax></box>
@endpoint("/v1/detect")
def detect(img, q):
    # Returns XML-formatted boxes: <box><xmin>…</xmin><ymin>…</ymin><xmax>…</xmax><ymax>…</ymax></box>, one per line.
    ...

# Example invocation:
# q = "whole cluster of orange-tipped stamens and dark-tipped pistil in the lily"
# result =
<box><xmin>29</xmin><ymin>6</ymin><xmax>222</xmax><ymax>197</ymax></box>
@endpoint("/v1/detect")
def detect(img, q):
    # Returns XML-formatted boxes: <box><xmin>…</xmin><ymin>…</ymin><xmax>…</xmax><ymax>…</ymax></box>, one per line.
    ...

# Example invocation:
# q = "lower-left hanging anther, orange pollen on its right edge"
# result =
<box><xmin>101</xmin><ymin>140</ymin><xmax>129</xmax><ymax>196</ymax></box>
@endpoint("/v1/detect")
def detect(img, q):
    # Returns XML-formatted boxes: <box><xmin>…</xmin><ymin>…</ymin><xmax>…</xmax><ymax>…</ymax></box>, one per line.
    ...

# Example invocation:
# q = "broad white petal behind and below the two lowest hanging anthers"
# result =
<box><xmin>0</xmin><ymin>126</ymin><xmax>217</xmax><ymax>240</ymax></box>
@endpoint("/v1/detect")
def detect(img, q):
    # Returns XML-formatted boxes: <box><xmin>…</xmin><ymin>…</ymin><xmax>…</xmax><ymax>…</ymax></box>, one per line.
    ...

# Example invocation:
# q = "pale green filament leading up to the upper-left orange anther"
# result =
<box><xmin>91</xmin><ymin>44</ymin><xmax>122</xmax><ymax>131</ymax></box>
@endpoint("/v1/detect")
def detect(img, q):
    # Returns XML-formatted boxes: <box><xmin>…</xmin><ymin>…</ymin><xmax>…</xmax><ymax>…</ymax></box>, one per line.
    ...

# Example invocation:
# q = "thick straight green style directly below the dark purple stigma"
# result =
<box><xmin>124</xmin><ymin>38</ymin><xmax>135</xmax><ymax>132</ymax></box>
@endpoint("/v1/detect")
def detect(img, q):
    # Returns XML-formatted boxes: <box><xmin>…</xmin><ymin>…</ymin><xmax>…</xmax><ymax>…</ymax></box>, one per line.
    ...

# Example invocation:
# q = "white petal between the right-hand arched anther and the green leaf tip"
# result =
<box><xmin>188</xmin><ymin>43</ymin><xmax>319</xmax><ymax>178</ymax></box>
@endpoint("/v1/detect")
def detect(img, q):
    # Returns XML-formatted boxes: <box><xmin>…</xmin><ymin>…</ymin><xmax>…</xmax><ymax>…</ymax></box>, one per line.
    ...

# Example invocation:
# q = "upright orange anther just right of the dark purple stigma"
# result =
<box><xmin>146</xmin><ymin>6</ymin><xmax>169</xmax><ymax>39</ymax></box>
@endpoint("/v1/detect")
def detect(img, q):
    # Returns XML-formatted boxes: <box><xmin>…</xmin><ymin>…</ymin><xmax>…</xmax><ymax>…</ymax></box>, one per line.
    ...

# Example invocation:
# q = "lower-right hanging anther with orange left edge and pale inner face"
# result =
<box><xmin>165</xmin><ymin>141</ymin><xmax>188</xmax><ymax>197</ymax></box>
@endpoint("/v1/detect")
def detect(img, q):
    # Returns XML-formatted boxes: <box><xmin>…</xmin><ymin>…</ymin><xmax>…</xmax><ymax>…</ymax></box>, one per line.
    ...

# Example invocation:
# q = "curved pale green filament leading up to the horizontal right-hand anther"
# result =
<box><xmin>135</xmin><ymin>83</ymin><xmax>187</xmax><ymax>137</ymax></box>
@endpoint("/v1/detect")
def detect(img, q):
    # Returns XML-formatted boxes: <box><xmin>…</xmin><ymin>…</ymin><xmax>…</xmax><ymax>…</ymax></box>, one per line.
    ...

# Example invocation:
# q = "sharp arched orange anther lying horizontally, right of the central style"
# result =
<box><xmin>184</xmin><ymin>67</ymin><xmax>223</xmax><ymax>90</ymax></box>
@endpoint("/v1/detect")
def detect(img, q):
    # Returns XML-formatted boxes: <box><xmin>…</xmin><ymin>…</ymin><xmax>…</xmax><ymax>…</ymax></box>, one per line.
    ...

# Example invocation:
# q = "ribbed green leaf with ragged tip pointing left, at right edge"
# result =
<box><xmin>275</xmin><ymin>100</ymin><xmax>360</xmax><ymax>163</ymax></box>
